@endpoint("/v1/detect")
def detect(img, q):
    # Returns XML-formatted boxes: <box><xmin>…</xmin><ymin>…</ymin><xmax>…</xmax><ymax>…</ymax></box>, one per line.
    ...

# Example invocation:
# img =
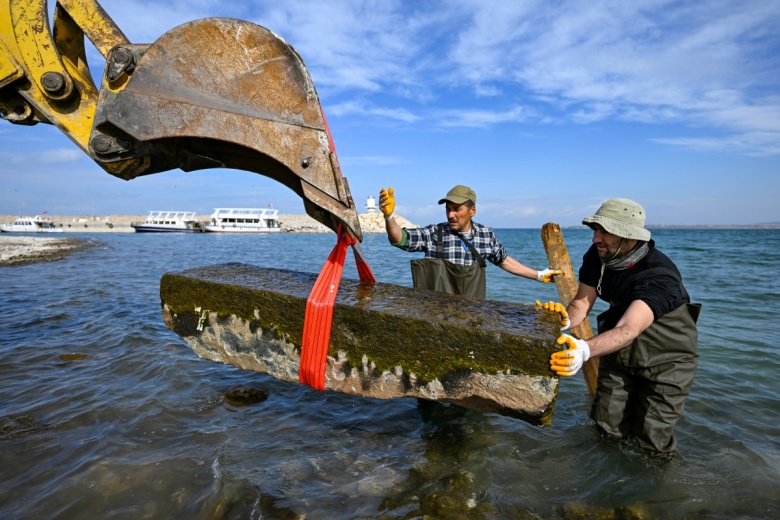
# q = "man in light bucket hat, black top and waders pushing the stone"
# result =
<box><xmin>550</xmin><ymin>199</ymin><xmax>700</xmax><ymax>456</ymax></box>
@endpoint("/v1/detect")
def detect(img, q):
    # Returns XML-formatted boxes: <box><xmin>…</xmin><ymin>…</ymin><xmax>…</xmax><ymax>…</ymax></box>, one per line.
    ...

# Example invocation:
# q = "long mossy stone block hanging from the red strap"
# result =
<box><xmin>160</xmin><ymin>264</ymin><xmax>560</xmax><ymax>425</ymax></box>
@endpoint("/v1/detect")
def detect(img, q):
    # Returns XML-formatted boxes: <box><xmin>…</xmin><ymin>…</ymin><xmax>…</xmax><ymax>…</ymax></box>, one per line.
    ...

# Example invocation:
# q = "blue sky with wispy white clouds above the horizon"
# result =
<box><xmin>0</xmin><ymin>0</ymin><xmax>780</xmax><ymax>228</ymax></box>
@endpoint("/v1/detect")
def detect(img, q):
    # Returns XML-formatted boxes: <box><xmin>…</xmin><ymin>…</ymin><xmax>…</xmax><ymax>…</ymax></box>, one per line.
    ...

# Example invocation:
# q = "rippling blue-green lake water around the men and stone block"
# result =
<box><xmin>0</xmin><ymin>229</ymin><xmax>780</xmax><ymax>519</ymax></box>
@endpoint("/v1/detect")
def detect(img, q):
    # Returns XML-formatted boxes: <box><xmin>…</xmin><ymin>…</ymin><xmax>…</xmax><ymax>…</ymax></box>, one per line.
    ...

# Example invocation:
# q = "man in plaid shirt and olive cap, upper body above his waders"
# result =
<box><xmin>379</xmin><ymin>185</ymin><xmax>561</xmax><ymax>294</ymax></box>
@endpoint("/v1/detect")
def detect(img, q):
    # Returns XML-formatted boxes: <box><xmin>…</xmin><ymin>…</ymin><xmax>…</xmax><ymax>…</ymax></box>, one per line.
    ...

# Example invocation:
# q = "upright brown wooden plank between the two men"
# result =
<box><xmin>542</xmin><ymin>222</ymin><xmax>599</xmax><ymax>395</ymax></box>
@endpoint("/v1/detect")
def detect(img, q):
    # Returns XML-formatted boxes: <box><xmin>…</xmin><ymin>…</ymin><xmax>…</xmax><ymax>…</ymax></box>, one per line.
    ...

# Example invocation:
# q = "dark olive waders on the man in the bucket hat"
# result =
<box><xmin>590</xmin><ymin>270</ymin><xmax>701</xmax><ymax>455</ymax></box>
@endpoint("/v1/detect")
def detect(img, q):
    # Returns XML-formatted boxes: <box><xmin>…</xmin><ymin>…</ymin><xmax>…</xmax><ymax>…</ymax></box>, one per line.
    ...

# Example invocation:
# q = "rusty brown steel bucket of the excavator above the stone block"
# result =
<box><xmin>90</xmin><ymin>18</ymin><xmax>362</xmax><ymax>239</ymax></box>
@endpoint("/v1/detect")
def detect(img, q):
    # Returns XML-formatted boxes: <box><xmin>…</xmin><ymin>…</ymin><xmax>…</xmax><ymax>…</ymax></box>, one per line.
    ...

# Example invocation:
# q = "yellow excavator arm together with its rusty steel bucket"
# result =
<box><xmin>0</xmin><ymin>0</ymin><xmax>362</xmax><ymax>240</ymax></box>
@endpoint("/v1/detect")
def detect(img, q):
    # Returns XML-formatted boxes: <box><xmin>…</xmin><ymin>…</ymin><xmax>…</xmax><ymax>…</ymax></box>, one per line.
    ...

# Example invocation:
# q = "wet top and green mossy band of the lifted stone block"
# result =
<box><xmin>160</xmin><ymin>264</ymin><xmax>560</xmax><ymax>381</ymax></box>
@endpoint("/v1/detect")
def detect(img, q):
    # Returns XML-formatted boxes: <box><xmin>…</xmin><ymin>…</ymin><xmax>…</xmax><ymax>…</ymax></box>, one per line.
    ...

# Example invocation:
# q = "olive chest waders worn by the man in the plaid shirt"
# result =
<box><xmin>411</xmin><ymin>226</ymin><xmax>487</xmax><ymax>299</ymax></box>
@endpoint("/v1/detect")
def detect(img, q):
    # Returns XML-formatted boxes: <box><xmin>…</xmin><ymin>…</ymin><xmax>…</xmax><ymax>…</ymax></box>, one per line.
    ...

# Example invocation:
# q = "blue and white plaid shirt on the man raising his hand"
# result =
<box><xmin>395</xmin><ymin>222</ymin><xmax>507</xmax><ymax>266</ymax></box>
